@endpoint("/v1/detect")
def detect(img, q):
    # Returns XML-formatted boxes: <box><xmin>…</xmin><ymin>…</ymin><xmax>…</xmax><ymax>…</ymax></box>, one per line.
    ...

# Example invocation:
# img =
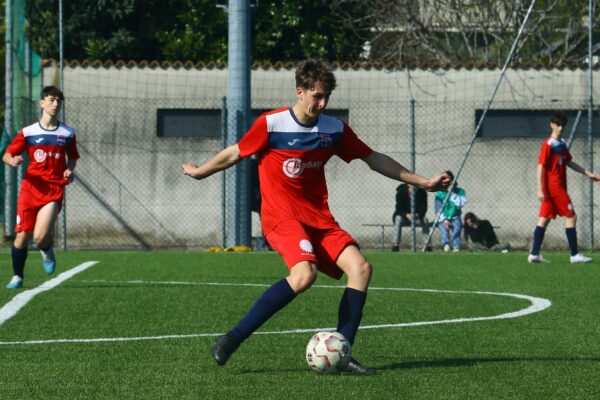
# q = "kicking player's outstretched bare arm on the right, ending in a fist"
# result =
<box><xmin>362</xmin><ymin>151</ymin><xmax>450</xmax><ymax>192</ymax></box>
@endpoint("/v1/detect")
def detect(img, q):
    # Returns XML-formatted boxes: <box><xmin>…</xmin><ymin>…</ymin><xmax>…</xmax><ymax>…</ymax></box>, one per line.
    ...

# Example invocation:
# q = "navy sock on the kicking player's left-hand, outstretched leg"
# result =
<box><xmin>231</xmin><ymin>279</ymin><xmax>296</xmax><ymax>342</ymax></box>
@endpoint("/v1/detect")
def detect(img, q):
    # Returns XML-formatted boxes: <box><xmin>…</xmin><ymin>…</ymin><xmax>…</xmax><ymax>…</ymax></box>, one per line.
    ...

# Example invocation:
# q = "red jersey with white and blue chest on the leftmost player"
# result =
<box><xmin>6</xmin><ymin>122</ymin><xmax>79</xmax><ymax>185</ymax></box>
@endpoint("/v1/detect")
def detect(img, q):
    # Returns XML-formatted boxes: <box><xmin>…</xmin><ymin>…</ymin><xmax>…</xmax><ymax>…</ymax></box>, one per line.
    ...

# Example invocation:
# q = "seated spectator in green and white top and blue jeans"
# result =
<box><xmin>435</xmin><ymin>171</ymin><xmax>467</xmax><ymax>253</ymax></box>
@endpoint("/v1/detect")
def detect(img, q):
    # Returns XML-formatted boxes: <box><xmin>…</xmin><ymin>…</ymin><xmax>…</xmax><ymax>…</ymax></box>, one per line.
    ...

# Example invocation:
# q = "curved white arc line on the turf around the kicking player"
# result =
<box><xmin>0</xmin><ymin>280</ymin><xmax>552</xmax><ymax>345</ymax></box>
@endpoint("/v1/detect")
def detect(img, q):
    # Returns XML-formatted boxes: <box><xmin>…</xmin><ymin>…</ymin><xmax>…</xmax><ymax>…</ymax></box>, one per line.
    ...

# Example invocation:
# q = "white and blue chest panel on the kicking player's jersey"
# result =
<box><xmin>267</xmin><ymin>110</ymin><xmax>344</xmax><ymax>150</ymax></box>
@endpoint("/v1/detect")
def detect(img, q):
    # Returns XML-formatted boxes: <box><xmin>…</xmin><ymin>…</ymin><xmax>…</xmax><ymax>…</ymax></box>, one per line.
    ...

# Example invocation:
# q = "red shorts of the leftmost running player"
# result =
<box><xmin>15</xmin><ymin>179</ymin><xmax>65</xmax><ymax>232</ymax></box>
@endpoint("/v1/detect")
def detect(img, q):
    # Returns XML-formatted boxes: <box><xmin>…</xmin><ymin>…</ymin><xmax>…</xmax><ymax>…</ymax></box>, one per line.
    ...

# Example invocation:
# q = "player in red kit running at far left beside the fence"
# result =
<box><xmin>2</xmin><ymin>86</ymin><xmax>79</xmax><ymax>289</ymax></box>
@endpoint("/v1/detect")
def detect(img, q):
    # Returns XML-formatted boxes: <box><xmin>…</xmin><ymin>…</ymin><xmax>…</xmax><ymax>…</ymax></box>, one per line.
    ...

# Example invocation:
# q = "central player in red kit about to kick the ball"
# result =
<box><xmin>183</xmin><ymin>60</ymin><xmax>450</xmax><ymax>374</ymax></box>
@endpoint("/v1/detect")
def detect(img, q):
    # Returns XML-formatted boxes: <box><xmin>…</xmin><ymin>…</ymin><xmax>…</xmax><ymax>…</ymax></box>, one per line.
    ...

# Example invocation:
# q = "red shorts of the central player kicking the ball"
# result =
<box><xmin>266</xmin><ymin>220</ymin><xmax>358</xmax><ymax>279</ymax></box>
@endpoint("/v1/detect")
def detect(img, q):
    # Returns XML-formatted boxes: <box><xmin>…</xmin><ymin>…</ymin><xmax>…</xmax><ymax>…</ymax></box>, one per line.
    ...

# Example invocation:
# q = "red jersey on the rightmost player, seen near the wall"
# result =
<box><xmin>538</xmin><ymin>136</ymin><xmax>573</xmax><ymax>194</ymax></box>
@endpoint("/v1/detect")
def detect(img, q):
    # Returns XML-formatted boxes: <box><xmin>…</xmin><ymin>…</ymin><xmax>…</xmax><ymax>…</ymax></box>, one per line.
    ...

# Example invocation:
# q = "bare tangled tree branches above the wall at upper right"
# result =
<box><xmin>332</xmin><ymin>0</ymin><xmax>599</xmax><ymax>64</ymax></box>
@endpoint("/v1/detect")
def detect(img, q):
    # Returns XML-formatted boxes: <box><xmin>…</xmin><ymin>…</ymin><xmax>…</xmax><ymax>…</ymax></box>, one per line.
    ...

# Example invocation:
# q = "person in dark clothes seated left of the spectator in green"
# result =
<box><xmin>392</xmin><ymin>183</ymin><xmax>431</xmax><ymax>251</ymax></box>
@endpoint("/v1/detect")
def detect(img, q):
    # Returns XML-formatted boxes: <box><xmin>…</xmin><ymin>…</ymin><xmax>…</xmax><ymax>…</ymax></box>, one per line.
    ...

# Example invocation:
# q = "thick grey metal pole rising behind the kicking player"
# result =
<box><xmin>227</xmin><ymin>0</ymin><xmax>252</xmax><ymax>246</ymax></box>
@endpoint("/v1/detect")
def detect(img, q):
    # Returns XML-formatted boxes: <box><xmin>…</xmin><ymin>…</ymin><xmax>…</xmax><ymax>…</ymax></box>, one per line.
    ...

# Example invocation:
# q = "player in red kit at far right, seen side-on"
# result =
<box><xmin>527</xmin><ymin>111</ymin><xmax>600</xmax><ymax>263</ymax></box>
